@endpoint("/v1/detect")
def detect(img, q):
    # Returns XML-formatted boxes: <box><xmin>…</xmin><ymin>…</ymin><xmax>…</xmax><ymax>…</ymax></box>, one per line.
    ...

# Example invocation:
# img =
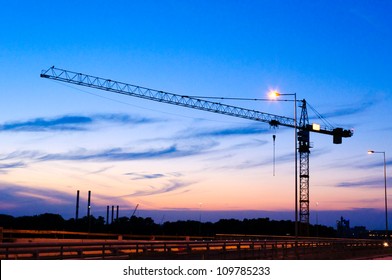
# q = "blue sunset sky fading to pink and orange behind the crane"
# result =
<box><xmin>0</xmin><ymin>0</ymin><xmax>392</xmax><ymax>228</ymax></box>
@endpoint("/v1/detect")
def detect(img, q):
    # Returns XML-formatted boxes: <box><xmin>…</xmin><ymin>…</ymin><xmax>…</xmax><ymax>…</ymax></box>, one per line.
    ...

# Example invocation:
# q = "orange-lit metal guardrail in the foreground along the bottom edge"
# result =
<box><xmin>0</xmin><ymin>239</ymin><xmax>392</xmax><ymax>259</ymax></box>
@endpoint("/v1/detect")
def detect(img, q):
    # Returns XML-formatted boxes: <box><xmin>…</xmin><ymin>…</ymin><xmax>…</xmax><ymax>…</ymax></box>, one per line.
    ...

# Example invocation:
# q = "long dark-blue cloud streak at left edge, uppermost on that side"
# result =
<box><xmin>0</xmin><ymin>114</ymin><xmax>158</xmax><ymax>132</ymax></box>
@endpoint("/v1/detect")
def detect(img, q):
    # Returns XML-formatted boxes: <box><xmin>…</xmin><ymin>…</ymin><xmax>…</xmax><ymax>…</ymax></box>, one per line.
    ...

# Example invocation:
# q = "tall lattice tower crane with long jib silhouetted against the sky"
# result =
<box><xmin>40</xmin><ymin>66</ymin><xmax>353</xmax><ymax>234</ymax></box>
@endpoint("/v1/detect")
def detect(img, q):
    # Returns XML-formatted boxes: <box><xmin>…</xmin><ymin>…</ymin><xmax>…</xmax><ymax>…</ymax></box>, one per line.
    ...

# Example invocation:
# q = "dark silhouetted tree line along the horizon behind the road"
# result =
<box><xmin>0</xmin><ymin>213</ymin><xmax>337</xmax><ymax>237</ymax></box>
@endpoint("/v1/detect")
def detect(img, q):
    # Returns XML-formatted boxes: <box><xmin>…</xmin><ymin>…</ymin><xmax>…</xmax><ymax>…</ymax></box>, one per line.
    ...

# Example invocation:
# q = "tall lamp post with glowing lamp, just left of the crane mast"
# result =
<box><xmin>270</xmin><ymin>91</ymin><xmax>298</xmax><ymax>238</ymax></box>
